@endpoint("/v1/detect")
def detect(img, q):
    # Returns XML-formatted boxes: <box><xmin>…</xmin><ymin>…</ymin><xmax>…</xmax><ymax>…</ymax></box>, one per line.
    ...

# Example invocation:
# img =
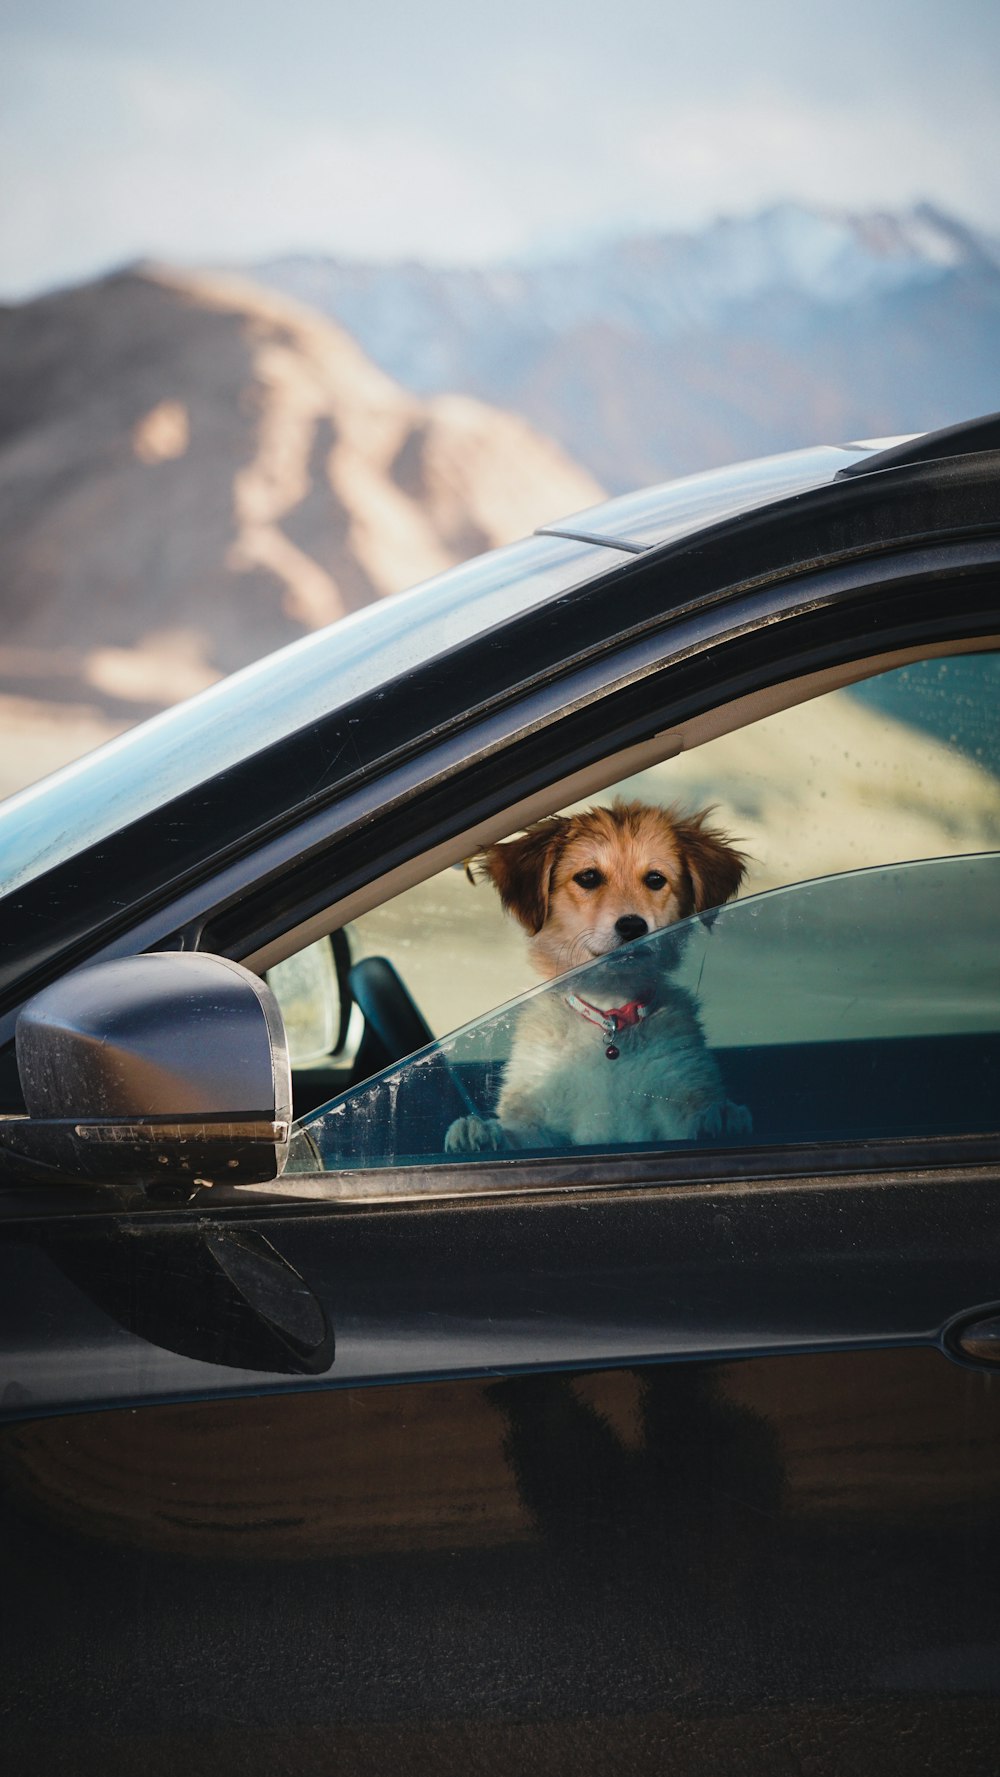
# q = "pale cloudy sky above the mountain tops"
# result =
<box><xmin>0</xmin><ymin>13</ymin><xmax>1000</xmax><ymax>297</ymax></box>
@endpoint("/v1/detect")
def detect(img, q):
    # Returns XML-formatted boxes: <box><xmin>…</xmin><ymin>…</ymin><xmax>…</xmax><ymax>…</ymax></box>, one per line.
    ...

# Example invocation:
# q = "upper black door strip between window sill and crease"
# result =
<box><xmin>0</xmin><ymin>1160</ymin><xmax>1000</xmax><ymax>1413</ymax></box>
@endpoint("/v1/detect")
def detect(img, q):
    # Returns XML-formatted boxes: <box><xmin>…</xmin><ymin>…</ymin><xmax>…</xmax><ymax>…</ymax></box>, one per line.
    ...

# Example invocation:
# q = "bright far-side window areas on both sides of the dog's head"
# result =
<box><xmin>350</xmin><ymin>652</ymin><xmax>1000</xmax><ymax>1036</ymax></box>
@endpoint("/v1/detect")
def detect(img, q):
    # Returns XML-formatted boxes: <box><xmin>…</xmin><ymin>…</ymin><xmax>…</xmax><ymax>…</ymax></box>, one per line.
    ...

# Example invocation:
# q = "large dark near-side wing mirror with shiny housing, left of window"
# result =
<box><xmin>0</xmin><ymin>951</ymin><xmax>291</xmax><ymax>1183</ymax></box>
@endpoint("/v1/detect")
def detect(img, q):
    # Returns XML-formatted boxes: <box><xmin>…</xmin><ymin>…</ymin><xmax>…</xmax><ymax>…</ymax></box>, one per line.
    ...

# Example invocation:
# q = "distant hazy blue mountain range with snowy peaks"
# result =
<box><xmin>254</xmin><ymin>204</ymin><xmax>1000</xmax><ymax>490</ymax></box>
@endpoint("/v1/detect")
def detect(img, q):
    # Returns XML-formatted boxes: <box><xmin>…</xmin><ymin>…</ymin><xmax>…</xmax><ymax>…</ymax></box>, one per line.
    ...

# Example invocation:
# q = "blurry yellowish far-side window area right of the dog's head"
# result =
<box><xmin>629</xmin><ymin>654</ymin><xmax>1000</xmax><ymax>894</ymax></box>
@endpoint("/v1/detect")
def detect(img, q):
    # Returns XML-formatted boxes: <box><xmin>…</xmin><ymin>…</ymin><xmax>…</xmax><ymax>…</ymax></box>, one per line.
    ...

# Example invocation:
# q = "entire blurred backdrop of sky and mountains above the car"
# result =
<box><xmin>0</xmin><ymin>0</ymin><xmax>1000</xmax><ymax>813</ymax></box>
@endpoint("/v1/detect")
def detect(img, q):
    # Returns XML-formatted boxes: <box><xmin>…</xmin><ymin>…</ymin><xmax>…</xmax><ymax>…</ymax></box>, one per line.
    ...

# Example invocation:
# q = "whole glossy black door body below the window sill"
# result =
<box><xmin>0</xmin><ymin>1157</ymin><xmax>1000</xmax><ymax>1773</ymax></box>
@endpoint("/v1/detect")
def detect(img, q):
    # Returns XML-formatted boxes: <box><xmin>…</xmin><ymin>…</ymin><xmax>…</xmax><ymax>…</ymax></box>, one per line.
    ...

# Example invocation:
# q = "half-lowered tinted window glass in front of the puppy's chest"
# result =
<box><xmin>290</xmin><ymin>853</ymin><xmax>1000</xmax><ymax>1173</ymax></box>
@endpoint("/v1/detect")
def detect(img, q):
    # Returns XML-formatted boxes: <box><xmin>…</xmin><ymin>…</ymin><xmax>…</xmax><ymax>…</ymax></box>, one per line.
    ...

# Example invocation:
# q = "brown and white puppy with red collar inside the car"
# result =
<box><xmin>444</xmin><ymin>801</ymin><xmax>751</xmax><ymax>1153</ymax></box>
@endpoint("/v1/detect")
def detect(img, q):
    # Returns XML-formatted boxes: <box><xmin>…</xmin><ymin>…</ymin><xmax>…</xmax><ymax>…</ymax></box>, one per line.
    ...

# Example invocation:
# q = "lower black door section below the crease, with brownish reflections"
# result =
<box><xmin>0</xmin><ymin>1349</ymin><xmax>1000</xmax><ymax>1773</ymax></box>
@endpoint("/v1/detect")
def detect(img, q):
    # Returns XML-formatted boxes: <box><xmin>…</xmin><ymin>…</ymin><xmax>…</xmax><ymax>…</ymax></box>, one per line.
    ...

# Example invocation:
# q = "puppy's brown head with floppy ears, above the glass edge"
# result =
<box><xmin>480</xmin><ymin>801</ymin><xmax>746</xmax><ymax>976</ymax></box>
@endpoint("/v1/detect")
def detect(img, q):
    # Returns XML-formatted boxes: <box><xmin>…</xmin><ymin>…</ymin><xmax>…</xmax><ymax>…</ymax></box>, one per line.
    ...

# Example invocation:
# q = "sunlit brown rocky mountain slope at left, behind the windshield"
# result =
<box><xmin>0</xmin><ymin>268</ymin><xmax>600</xmax><ymax>739</ymax></box>
